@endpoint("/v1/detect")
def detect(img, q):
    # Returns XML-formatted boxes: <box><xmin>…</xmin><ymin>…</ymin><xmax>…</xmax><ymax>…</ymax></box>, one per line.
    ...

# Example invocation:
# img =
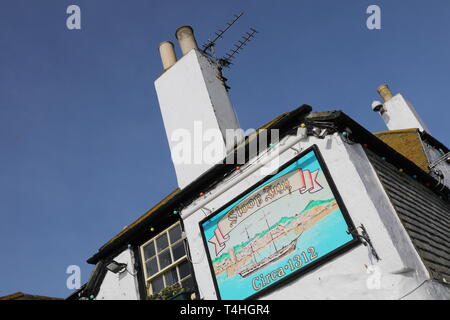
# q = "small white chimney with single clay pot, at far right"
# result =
<box><xmin>372</xmin><ymin>84</ymin><xmax>430</xmax><ymax>133</ymax></box>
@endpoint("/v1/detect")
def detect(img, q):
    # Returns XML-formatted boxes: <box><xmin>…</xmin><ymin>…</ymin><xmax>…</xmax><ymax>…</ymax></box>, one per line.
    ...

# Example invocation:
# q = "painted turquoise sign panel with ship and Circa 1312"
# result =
<box><xmin>201</xmin><ymin>150</ymin><xmax>353</xmax><ymax>300</ymax></box>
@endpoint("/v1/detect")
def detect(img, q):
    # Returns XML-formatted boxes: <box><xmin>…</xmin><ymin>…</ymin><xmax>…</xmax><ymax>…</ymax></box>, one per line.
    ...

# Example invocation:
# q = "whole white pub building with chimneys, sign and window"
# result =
<box><xmin>70</xmin><ymin>27</ymin><xmax>450</xmax><ymax>300</ymax></box>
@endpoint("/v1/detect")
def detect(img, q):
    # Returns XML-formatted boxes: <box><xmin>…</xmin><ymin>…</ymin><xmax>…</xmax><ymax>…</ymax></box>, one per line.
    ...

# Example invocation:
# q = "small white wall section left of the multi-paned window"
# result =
<box><xmin>95</xmin><ymin>249</ymin><xmax>139</xmax><ymax>300</ymax></box>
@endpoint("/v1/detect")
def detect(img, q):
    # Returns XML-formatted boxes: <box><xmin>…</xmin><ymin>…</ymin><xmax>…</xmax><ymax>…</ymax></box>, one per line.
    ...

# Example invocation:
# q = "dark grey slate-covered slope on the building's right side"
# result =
<box><xmin>367</xmin><ymin>150</ymin><xmax>450</xmax><ymax>284</ymax></box>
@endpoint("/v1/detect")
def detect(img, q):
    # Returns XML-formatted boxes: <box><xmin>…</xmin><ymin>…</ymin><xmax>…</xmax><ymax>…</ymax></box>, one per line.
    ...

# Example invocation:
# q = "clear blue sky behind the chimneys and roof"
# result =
<box><xmin>0</xmin><ymin>0</ymin><xmax>450</xmax><ymax>297</ymax></box>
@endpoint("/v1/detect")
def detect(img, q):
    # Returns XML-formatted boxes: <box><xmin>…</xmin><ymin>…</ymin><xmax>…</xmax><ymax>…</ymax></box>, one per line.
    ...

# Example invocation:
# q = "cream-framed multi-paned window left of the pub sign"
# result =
<box><xmin>141</xmin><ymin>223</ymin><xmax>194</xmax><ymax>294</ymax></box>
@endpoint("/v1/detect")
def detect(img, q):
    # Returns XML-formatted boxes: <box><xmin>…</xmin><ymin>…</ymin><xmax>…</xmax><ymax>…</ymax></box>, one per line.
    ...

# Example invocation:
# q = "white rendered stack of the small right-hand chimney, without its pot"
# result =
<box><xmin>381</xmin><ymin>94</ymin><xmax>430</xmax><ymax>133</ymax></box>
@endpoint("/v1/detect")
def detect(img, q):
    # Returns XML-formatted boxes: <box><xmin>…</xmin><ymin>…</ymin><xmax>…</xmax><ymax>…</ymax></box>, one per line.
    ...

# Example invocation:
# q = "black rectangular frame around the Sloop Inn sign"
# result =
<box><xmin>199</xmin><ymin>144</ymin><xmax>361</xmax><ymax>300</ymax></box>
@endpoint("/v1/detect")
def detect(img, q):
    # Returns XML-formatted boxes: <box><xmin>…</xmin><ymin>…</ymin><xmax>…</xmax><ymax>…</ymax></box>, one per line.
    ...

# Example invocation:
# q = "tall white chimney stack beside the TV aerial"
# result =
<box><xmin>155</xmin><ymin>27</ymin><xmax>242</xmax><ymax>188</ymax></box>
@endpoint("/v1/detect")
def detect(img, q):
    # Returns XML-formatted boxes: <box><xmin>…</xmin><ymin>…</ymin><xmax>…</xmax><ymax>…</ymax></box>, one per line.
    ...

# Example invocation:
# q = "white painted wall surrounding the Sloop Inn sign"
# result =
<box><xmin>182</xmin><ymin>131</ymin><xmax>448</xmax><ymax>300</ymax></box>
